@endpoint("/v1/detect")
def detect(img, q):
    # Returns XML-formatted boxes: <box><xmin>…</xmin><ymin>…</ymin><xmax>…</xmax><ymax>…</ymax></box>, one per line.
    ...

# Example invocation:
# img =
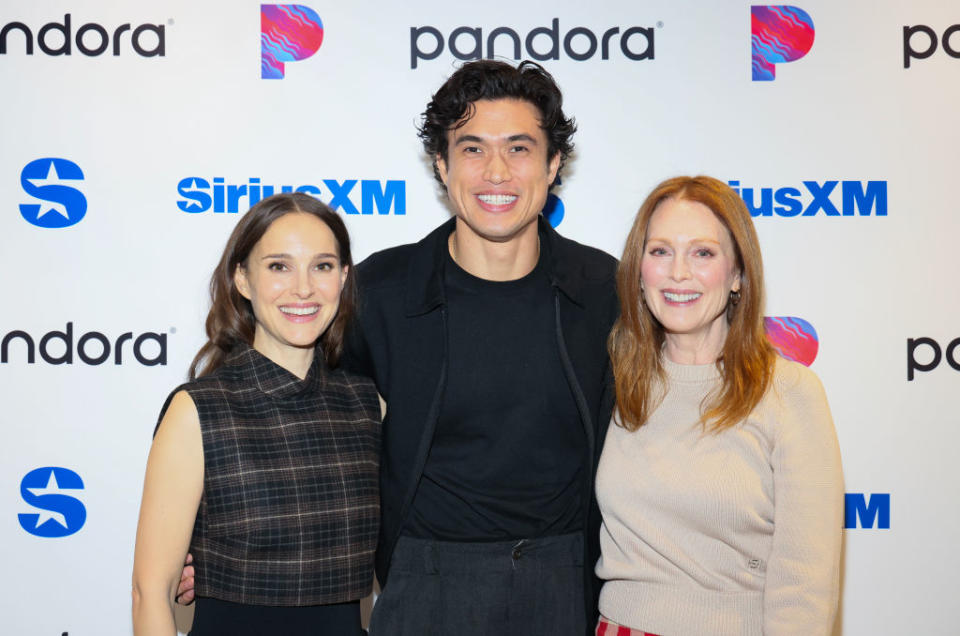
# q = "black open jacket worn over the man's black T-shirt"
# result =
<box><xmin>342</xmin><ymin>216</ymin><xmax>619</xmax><ymax>634</ymax></box>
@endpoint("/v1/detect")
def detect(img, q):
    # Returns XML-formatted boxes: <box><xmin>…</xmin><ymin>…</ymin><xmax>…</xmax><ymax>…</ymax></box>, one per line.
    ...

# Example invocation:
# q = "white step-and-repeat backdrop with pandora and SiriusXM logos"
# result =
<box><xmin>0</xmin><ymin>0</ymin><xmax>960</xmax><ymax>636</ymax></box>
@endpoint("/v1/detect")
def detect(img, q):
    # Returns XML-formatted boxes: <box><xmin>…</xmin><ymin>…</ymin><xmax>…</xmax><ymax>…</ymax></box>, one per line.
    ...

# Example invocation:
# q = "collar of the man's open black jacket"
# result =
<box><xmin>404</xmin><ymin>214</ymin><xmax>585</xmax><ymax>316</ymax></box>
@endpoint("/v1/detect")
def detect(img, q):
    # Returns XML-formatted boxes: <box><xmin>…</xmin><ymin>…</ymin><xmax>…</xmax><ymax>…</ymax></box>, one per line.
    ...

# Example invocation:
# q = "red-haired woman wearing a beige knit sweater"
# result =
<box><xmin>596</xmin><ymin>177</ymin><xmax>843</xmax><ymax>635</ymax></box>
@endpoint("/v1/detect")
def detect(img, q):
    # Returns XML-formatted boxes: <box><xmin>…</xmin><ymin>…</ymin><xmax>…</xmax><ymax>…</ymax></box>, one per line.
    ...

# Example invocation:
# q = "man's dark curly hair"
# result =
<box><xmin>418</xmin><ymin>60</ymin><xmax>577</xmax><ymax>187</ymax></box>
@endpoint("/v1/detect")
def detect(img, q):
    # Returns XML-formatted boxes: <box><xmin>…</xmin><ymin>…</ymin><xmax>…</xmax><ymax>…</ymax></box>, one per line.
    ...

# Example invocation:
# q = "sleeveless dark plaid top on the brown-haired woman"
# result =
<box><xmin>175</xmin><ymin>346</ymin><xmax>380</xmax><ymax>606</ymax></box>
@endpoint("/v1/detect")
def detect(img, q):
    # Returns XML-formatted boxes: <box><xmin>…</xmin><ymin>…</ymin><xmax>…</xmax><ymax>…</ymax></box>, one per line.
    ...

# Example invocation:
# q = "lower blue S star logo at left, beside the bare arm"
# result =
<box><xmin>17</xmin><ymin>466</ymin><xmax>87</xmax><ymax>538</ymax></box>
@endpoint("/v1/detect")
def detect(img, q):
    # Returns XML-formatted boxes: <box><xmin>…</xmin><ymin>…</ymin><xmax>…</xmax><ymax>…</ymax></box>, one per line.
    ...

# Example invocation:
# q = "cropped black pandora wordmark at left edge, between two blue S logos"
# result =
<box><xmin>0</xmin><ymin>322</ymin><xmax>167</xmax><ymax>367</ymax></box>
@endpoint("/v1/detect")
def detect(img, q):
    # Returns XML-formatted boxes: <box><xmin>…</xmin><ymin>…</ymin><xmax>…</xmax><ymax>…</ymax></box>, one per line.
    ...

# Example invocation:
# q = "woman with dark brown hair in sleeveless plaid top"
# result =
<box><xmin>133</xmin><ymin>194</ymin><xmax>380</xmax><ymax>636</ymax></box>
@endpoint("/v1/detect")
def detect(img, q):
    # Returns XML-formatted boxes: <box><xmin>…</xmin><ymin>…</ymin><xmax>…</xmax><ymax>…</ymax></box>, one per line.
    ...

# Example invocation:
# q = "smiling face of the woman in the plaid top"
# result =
<box><xmin>234</xmin><ymin>212</ymin><xmax>347</xmax><ymax>368</ymax></box>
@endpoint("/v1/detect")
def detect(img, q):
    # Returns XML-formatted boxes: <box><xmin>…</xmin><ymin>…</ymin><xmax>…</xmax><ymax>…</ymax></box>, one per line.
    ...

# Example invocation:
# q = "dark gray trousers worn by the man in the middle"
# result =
<box><xmin>370</xmin><ymin>533</ymin><xmax>586</xmax><ymax>636</ymax></box>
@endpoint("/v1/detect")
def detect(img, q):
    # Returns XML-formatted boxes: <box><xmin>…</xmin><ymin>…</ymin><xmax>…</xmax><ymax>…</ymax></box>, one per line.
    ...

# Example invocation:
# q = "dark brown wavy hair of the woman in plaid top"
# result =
<box><xmin>190</xmin><ymin>192</ymin><xmax>357</xmax><ymax>380</ymax></box>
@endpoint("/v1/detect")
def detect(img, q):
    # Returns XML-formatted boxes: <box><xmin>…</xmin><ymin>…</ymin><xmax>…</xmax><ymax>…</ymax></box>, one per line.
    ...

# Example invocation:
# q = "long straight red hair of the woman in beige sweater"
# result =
<box><xmin>607</xmin><ymin>176</ymin><xmax>776</xmax><ymax>431</ymax></box>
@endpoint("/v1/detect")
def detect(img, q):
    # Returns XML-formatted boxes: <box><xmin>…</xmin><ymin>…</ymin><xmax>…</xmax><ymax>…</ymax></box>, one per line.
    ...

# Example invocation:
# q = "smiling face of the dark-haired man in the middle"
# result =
<box><xmin>437</xmin><ymin>99</ymin><xmax>560</xmax><ymax>247</ymax></box>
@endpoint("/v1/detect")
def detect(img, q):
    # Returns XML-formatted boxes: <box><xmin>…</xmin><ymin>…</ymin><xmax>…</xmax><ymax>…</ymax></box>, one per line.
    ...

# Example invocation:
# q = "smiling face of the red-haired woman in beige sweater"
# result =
<box><xmin>640</xmin><ymin>198</ymin><xmax>740</xmax><ymax>362</ymax></box>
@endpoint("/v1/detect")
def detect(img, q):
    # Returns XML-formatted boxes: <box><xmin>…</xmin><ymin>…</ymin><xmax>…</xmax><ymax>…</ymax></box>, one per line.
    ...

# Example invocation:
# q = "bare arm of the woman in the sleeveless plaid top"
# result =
<box><xmin>133</xmin><ymin>391</ymin><xmax>203</xmax><ymax>636</ymax></box>
